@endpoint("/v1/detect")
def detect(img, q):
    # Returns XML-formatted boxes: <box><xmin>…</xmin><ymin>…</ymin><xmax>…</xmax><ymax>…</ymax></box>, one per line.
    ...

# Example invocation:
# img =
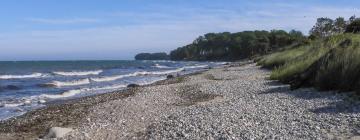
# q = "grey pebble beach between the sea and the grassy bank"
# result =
<box><xmin>0</xmin><ymin>63</ymin><xmax>360</xmax><ymax>139</ymax></box>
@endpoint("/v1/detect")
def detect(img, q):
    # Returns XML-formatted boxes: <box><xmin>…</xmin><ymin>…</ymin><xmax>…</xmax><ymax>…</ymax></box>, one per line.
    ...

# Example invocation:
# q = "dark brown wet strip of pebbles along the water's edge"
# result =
<box><xmin>0</xmin><ymin>66</ymin><xmax>214</xmax><ymax>139</ymax></box>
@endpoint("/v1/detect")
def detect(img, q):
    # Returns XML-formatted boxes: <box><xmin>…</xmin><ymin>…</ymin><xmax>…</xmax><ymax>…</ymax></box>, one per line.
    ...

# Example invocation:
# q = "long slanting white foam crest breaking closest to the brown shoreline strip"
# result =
<box><xmin>40</xmin><ymin>85</ymin><xmax>126</xmax><ymax>99</ymax></box>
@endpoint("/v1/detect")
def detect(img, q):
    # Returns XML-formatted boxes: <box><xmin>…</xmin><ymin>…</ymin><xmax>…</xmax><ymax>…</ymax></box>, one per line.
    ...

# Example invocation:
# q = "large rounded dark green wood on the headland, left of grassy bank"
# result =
<box><xmin>170</xmin><ymin>30</ymin><xmax>307</xmax><ymax>60</ymax></box>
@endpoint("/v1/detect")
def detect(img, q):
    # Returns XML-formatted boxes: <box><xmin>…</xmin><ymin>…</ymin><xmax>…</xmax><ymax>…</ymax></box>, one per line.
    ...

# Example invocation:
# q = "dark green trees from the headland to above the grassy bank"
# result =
<box><xmin>170</xmin><ymin>16</ymin><xmax>360</xmax><ymax>61</ymax></box>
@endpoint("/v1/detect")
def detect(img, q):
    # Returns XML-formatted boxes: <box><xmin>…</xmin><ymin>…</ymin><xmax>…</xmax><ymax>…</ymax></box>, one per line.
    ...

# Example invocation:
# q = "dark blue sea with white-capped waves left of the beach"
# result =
<box><xmin>0</xmin><ymin>60</ymin><xmax>224</xmax><ymax>120</ymax></box>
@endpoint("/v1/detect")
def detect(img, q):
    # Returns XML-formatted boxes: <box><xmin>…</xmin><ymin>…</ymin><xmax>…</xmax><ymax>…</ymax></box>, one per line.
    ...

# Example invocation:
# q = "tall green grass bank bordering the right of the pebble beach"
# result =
<box><xmin>258</xmin><ymin>34</ymin><xmax>360</xmax><ymax>91</ymax></box>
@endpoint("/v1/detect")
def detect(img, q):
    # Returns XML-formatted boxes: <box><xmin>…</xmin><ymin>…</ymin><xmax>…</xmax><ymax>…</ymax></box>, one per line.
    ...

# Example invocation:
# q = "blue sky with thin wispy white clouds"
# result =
<box><xmin>0</xmin><ymin>0</ymin><xmax>360</xmax><ymax>61</ymax></box>
